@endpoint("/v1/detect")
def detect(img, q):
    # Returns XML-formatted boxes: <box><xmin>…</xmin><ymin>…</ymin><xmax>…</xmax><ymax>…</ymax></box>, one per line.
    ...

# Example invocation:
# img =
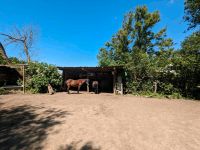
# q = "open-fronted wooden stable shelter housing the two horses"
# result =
<box><xmin>58</xmin><ymin>66</ymin><xmax>124</xmax><ymax>94</ymax></box>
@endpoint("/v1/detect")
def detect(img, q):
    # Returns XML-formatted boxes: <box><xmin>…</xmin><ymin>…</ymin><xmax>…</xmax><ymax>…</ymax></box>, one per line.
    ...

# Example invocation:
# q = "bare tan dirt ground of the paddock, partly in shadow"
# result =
<box><xmin>0</xmin><ymin>93</ymin><xmax>200</xmax><ymax>150</ymax></box>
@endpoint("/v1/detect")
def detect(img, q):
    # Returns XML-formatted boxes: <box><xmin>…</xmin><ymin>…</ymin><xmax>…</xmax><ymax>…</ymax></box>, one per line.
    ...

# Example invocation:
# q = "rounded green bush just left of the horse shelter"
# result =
<box><xmin>26</xmin><ymin>62</ymin><xmax>62</xmax><ymax>93</ymax></box>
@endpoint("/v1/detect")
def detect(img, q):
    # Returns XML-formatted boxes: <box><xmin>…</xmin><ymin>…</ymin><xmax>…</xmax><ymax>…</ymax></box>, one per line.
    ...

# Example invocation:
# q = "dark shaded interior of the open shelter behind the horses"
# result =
<box><xmin>58</xmin><ymin>67</ymin><xmax>121</xmax><ymax>93</ymax></box>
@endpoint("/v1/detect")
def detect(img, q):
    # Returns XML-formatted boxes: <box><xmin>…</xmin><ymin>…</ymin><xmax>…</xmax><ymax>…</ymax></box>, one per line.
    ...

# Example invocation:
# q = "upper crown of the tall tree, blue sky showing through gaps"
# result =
<box><xmin>98</xmin><ymin>6</ymin><xmax>171</xmax><ymax>65</ymax></box>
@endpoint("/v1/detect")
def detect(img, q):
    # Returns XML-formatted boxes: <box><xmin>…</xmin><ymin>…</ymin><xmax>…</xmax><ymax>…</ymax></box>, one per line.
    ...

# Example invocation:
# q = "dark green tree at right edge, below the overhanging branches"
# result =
<box><xmin>176</xmin><ymin>32</ymin><xmax>200</xmax><ymax>98</ymax></box>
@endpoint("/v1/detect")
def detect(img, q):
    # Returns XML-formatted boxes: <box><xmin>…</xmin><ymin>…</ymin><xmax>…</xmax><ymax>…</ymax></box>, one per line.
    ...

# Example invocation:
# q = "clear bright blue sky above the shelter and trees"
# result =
<box><xmin>0</xmin><ymin>0</ymin><xmax>189</xmax><ymax>66</ymax></box>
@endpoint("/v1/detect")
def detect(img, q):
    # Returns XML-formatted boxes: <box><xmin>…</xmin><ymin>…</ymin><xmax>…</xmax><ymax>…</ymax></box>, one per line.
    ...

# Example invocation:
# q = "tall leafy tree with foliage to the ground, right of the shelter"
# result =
<box><xmin>98</xmin><ymin>6</ymin><xmax>173</xmax><ymax>95</ymax></box>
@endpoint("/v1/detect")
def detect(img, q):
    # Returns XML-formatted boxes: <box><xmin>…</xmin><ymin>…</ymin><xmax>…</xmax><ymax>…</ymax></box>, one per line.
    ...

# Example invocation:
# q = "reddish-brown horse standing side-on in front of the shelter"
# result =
<box><xmin>65</xmin><ymin>79</ymin><xmax>89</xmax><ymax>94</ymax></box>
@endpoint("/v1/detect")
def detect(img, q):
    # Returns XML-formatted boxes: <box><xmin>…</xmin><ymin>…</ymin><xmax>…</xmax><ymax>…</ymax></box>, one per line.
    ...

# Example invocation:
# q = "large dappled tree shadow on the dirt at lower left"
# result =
<box><xmin>0</xmin><ymin>105</ymin><xmax>70</xmax><ymax>150</ymax></box>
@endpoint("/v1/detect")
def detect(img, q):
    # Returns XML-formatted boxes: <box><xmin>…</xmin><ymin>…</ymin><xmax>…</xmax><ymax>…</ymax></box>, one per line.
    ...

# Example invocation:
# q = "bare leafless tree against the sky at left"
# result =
<box><xmin>0</xmin><ymin>27</ymin><xmax>36</xmax><ymax>63</ymax></box>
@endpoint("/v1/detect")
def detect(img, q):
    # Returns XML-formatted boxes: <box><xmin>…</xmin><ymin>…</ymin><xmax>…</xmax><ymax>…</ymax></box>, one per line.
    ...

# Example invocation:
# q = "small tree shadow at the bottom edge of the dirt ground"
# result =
<box><xmin>58</xmin><ymin>142</ymin><xmax>101</xmax><ymax>150</ymax></box>
